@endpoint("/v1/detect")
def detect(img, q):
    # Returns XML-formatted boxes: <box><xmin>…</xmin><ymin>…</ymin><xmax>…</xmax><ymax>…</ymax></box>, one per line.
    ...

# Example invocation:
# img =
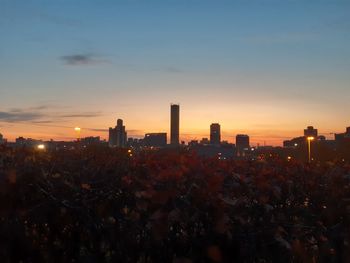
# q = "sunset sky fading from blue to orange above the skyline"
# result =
<box><xmin>0</xmin><ymin>0</ymin><xmax>350</xmax><ymax>145</ymax></box>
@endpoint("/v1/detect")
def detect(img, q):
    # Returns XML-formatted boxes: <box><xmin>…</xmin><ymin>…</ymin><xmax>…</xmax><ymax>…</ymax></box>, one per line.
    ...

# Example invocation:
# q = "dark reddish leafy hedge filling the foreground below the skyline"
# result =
<box><xmin>0</xmin><ymin>145</ymin><xmax>350</xmax><ymax>263</ymax></box>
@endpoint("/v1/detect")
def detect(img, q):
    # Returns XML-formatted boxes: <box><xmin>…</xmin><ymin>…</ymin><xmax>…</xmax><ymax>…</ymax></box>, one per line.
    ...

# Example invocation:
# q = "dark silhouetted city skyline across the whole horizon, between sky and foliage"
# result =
<box><xmin>0</xmin><ymin>104</ymin><xmax>350</xmax><ymax>161</ymax></box>
